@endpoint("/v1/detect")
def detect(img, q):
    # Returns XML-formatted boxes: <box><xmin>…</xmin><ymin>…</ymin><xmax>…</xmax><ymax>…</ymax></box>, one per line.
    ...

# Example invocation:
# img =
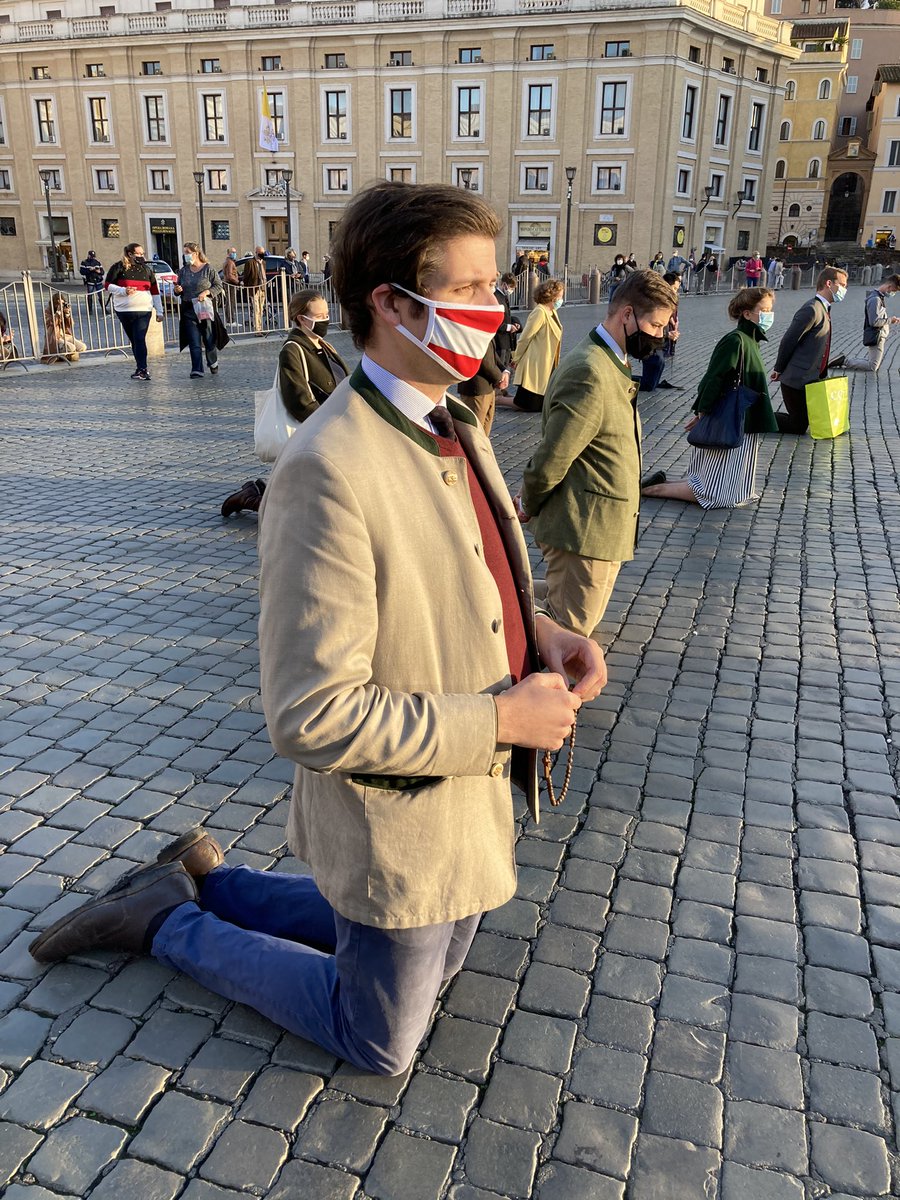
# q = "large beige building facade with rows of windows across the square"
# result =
<box><xmin>0</xmin><ymin>0</ymin><xmax>796</xmax><ymax>277</ymax></box>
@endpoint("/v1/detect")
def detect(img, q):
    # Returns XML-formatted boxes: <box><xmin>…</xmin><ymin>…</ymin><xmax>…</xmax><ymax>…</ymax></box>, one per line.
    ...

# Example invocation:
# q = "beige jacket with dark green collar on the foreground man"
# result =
<box><xmin>259</xmin><ymin>368</ymin><xmax>536</xmax><ymax>929</ymax></box>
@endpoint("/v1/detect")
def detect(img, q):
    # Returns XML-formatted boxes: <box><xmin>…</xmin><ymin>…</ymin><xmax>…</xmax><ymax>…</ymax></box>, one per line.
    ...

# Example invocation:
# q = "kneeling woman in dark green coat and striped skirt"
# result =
<box><xmin>641</xmin><ymin>288</ymin><xmax>778</xmax><ymax>509</ymax></box>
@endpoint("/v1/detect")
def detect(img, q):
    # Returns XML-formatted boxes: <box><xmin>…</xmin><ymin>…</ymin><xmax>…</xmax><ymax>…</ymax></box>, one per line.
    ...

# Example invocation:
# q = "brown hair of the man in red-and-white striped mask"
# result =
<box><xmin>331</xmin><ymin>182</ymin><xmax>500</xmax><ymax>348</ymax></box>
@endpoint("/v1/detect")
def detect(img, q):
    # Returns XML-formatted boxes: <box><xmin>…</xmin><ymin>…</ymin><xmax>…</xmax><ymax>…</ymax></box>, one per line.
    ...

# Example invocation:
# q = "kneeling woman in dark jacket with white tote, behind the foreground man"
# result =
<box><xmin>222</xmin><ymin>289</ymin><xmax>348</xmax><ymax>517</ymax></box>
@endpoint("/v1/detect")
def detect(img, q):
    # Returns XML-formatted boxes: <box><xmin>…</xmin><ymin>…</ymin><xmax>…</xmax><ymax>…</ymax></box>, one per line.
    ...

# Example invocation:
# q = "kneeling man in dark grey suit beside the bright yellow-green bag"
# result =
<box><xmin>772</xmin><ymin>266</ymin><xmax>847</xmax><ymax>433</ymax></box>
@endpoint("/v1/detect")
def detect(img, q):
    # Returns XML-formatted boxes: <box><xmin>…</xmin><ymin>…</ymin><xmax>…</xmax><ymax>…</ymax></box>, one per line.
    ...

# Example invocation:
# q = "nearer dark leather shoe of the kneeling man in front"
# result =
<box><xmin>29</xmin><ymin>863</ymin><xmax>197</xmax><ymax>962</ymax></box>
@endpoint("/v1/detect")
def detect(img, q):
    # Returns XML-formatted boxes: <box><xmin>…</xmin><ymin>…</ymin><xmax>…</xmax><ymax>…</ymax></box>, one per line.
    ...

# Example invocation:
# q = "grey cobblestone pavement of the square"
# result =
<box><xmin>0</xmin><ymin>290</ymin><xmax>900</xmax><ymax>1200</ymax></box>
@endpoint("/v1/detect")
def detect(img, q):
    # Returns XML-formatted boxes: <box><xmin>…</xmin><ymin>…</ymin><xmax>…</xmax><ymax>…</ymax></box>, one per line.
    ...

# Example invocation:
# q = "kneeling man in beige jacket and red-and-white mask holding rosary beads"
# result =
<box><xmin>30</xmin><ymin>182</ymin><xmax>606</xmax><ymax>1075</ymax></box>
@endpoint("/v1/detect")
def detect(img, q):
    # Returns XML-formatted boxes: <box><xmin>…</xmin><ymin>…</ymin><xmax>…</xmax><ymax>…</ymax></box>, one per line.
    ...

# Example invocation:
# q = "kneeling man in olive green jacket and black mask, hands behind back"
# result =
<box><xmin>520</xmin><ymin>271</ymin><xmax>677</xmax><ymax>637</ymax></box>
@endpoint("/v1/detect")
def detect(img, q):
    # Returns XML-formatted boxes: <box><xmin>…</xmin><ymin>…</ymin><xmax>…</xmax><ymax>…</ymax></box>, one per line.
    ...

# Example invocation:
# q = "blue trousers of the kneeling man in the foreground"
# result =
<box><xmin>152</xmin><ymin>866</ymin><xmax>481</xmax><ymax>1075</ymax></box>
